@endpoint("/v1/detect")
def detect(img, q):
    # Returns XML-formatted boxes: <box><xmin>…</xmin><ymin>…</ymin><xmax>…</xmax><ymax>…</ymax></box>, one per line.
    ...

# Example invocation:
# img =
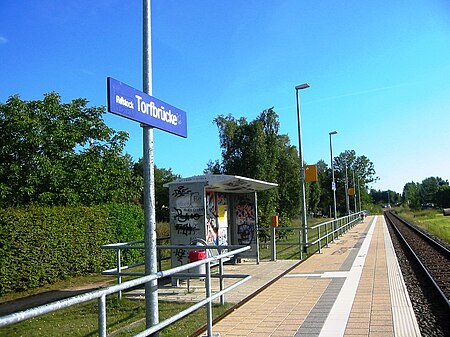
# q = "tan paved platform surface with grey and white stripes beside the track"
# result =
<box><xmin>207</xmin><ymin>216</ymin><xmax>420</xmax><ymax>337</ymax></box>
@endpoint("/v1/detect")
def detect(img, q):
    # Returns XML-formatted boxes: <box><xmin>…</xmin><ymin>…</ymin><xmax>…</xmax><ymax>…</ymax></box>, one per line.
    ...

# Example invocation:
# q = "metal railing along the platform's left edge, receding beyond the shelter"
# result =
<box><xmin>259</xmin><ymin>211</ymin><xmax>366</xmax><ymax>261</ymax></box>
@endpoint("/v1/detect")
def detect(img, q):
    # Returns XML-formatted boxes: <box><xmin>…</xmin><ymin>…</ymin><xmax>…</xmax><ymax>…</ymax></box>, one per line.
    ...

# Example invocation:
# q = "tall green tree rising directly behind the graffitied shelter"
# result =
<box><xmin>214</xmin><ymin>108</ymin><xmax>298</xmax><ymax>224</ymax></box>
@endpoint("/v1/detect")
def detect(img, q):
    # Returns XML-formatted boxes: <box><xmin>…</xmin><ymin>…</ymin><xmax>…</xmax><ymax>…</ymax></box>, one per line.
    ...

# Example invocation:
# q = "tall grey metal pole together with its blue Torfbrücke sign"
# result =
<box><xmin>107</xmin><ymin>0</ymin><xmax>187</xmax><ymax>337</ymax></box>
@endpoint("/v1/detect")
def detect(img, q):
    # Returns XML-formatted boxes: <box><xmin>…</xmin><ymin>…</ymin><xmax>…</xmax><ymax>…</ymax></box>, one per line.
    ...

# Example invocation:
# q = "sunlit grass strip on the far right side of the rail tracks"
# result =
<box><xmin>398</xmin><ymin>209</ymin><xmax>450</xmax><ymax>243</ymax></box>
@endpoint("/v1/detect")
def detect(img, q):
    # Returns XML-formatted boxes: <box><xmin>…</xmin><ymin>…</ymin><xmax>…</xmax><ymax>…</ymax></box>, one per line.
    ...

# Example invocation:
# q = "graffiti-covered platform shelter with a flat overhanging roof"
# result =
<box><xmin>165</xmin><ymin>175</ymin><xmax>277</xmax><ymax>267</ymax></box>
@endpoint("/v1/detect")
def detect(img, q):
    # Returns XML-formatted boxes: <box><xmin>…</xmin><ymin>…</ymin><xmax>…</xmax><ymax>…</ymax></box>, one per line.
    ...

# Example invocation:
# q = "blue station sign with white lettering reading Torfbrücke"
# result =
<box><xmin>107</xmin><ymin>77</ymin><xmax>187</xmax><ymax>138</ymax></box>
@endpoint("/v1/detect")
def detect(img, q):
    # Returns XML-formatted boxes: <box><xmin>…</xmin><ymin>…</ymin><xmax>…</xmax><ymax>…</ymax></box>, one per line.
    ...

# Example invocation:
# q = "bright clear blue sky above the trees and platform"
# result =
<box><xmin>0</xmin><ymin>0</ymin><xmax>450</xmax><ymax>193</ymax></box>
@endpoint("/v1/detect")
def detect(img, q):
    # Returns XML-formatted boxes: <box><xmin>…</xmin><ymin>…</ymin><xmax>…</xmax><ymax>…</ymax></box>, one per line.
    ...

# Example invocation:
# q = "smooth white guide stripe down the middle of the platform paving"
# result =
<box><xmin>319</xmin><ymin>216</ymin><xmax>377</xmax><ymax>337</ymax></box>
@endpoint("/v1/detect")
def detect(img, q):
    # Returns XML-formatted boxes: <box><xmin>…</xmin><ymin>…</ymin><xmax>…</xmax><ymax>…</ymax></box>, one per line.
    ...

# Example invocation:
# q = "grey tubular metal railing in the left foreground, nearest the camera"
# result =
<box><xmin>0</xmin><ymin>246</ymin><xmax>251</xmax><ymax>337</ymax></box>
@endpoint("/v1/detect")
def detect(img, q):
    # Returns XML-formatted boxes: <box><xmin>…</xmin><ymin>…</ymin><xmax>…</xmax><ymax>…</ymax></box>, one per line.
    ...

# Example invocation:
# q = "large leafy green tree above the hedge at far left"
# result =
<box><xmin>0</xmin><ymin>93</ymin><xmax>142</xmax><ymax>207</ymax></box>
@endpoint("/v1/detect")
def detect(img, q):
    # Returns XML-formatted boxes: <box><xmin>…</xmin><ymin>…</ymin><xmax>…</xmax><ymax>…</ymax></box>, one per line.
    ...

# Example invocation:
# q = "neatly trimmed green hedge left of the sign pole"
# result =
<box><xmin>0</xmin><ymin>204</ymin><xmax>143</xmax><ymax>295</ymax></box>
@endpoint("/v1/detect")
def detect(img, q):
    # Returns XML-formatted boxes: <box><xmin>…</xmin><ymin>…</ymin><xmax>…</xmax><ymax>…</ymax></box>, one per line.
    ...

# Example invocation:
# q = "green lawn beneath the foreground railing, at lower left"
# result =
<box><xmin>0</xmin><ymin>275</ymin><xmax>236</xmax><ymax>337</ymax></box>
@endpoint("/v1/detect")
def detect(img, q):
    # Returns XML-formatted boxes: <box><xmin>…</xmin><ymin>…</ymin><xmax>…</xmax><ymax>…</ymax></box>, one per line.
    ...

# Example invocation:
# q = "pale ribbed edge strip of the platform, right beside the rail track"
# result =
<box><xmin>383</xmin><ymin>217</ymin><xmax>421</xmax><ymax>337</ymax></box>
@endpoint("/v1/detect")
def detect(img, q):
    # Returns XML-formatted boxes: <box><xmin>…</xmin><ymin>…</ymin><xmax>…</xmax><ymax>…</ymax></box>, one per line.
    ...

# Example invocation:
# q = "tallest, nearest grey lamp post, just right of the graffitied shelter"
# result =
<box><xmin>295</xmin><ymin>83</ymin><xmax>309</xmax><ymax>254</ymax></box>
